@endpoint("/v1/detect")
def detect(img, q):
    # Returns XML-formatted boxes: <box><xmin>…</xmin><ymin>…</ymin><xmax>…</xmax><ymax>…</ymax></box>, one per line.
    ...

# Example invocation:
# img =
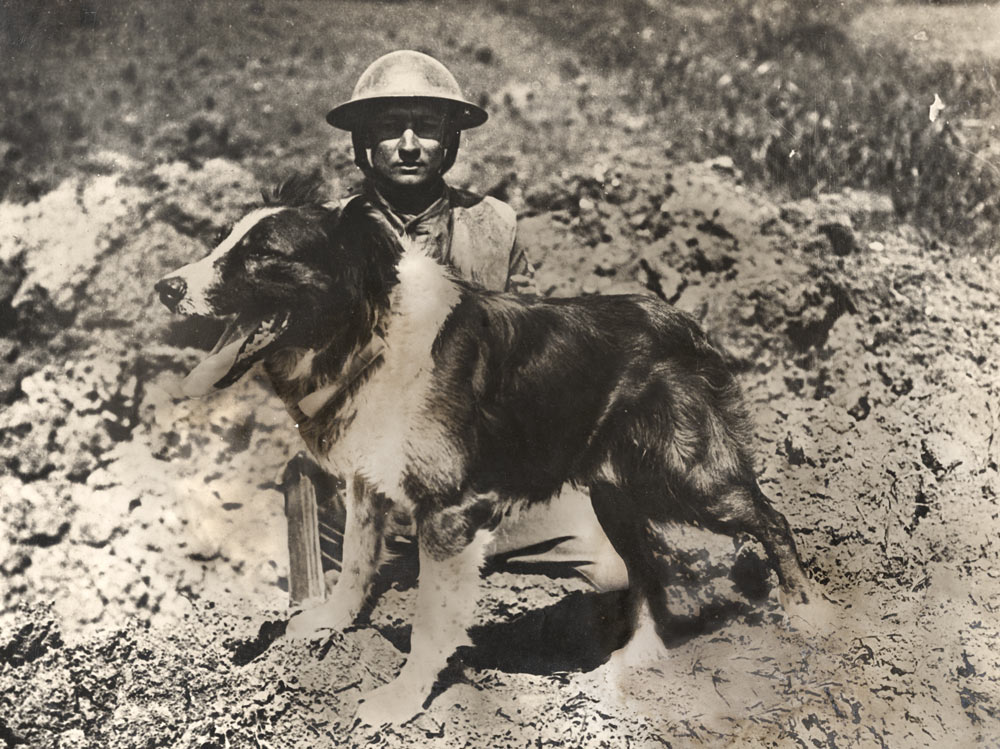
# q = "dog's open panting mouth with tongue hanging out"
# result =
<box><xmin>181</xmin><ymin>313</ymin><xmax>288</xmax><ymax>397</ymax></box>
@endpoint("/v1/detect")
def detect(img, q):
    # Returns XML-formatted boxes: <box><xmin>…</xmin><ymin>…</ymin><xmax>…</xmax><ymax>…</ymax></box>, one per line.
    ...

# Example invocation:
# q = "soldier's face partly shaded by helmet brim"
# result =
<box><xmin>366</xmin><ymin>103</ymin><xmax>445</xmax><ymax>187</ymax></box>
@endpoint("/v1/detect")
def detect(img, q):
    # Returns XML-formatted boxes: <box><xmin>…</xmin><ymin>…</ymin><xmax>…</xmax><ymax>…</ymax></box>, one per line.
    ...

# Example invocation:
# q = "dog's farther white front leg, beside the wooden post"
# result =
<box><xmin>285</xmin><ymin>476</ymin><xmax>389</xmax><ymax>638</ymax></box>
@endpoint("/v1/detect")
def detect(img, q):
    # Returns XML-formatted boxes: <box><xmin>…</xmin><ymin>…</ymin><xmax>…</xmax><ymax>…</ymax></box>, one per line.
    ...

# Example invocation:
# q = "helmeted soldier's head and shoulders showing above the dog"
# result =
<box><xmin>326</xmin><ymin>50</ymin><xmax>532</xmax><ymax>290</ymax></box>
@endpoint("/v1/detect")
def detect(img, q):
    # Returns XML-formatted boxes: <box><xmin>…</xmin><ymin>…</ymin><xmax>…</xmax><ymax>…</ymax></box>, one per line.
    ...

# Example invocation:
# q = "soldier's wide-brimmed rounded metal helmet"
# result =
<box><xmin>326</xmin><ymin>49</ymin><xmax>489</xmax><ymax>132</ymax></box>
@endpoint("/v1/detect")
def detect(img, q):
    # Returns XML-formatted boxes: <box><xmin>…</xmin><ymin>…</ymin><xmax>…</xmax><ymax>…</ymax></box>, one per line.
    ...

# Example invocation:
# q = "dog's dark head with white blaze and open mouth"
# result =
<box><xmin>155</xmin><ymin>177</ymin><xmax>397</xmax><ymax>395</ymax></box>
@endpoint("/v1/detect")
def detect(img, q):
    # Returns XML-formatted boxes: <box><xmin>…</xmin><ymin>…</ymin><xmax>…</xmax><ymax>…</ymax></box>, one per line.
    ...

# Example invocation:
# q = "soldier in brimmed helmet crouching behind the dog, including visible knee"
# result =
<box><xmin>286</xmin><ymin>50</ymin><xmax>627</xmax><ymax>620</ymax></box>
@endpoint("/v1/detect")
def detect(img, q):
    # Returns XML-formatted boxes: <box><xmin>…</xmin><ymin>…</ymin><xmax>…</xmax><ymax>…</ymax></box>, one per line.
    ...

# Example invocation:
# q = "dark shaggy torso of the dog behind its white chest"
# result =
<box><xmin>414</xmin><ymin>289</ymin><xmax>750</xmax><ymax>500</ymax></box>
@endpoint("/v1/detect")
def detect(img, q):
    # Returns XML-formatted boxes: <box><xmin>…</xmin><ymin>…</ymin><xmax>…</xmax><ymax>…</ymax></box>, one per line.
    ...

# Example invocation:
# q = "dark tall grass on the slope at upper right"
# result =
<box><xmin>495</xmin><ymin>0</ymin><xmax>1000</xmax><ymax>253</ymax></box>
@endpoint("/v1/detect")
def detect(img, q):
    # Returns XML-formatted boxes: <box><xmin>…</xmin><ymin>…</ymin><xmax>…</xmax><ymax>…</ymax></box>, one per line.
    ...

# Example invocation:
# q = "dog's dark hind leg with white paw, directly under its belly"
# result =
<box><xmin>590</xmin><ymin>483</ymin><xmax>670</xmax><ymax>666</ymax></box>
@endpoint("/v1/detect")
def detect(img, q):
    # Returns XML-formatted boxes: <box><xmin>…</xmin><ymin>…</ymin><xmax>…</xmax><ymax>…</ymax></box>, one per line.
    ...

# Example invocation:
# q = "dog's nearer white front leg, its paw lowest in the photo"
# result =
<box><xmin>358</xmin><ymin>508</ymin><xmax>492</xmax><ymax>727</ymax></box>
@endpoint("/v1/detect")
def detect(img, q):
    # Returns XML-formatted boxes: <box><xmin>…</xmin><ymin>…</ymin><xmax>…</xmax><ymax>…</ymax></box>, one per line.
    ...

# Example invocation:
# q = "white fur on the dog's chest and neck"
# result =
<box><xmin>327</xmin><ymin>240</ymin><xmax>460</xmax><ymax>504</ymax></box>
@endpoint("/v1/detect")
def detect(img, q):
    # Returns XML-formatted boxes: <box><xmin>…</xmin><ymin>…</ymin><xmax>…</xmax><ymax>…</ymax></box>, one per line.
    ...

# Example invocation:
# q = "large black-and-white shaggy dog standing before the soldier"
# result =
<box><xmin>156</xmin><ymin>174</ymin><xmax>820</xmax><ymax>726</ymax></box>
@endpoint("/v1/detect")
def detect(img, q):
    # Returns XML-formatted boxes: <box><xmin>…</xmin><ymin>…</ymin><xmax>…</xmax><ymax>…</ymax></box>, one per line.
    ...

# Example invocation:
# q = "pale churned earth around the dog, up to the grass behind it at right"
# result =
<box><xmin>0</xmin><ymin>154</ymin><xmax>1000</xmax><ymax>747</ymax></box>
